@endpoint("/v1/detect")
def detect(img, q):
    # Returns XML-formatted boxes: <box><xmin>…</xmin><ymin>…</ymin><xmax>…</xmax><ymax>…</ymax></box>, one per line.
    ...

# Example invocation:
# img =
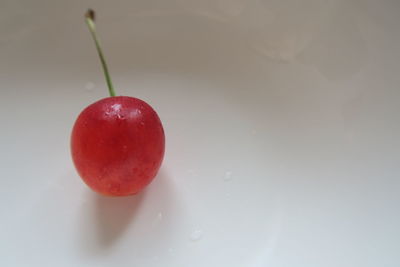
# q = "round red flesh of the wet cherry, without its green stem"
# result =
<box><xmin>71</xmin><ymin>96</ymin><xmax>165</xmax><ymax>196</ymax></box>
